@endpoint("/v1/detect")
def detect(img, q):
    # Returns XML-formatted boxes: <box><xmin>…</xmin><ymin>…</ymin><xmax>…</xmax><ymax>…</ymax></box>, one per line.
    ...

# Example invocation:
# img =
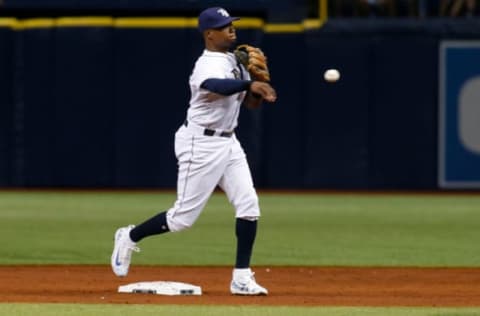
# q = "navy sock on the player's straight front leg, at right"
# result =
<box><xmin>235</xmin><ymin>218</ymin><xmax>257</xmax><ymax>269</ymax></box>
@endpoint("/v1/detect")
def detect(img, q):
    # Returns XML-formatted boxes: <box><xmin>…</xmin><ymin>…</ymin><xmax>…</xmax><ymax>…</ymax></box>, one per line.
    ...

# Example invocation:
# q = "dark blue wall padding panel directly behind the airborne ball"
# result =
<box><xmin>303</xmin><ymin>34</ymin><xmax>371</xmax><ymax>188</ymax></box>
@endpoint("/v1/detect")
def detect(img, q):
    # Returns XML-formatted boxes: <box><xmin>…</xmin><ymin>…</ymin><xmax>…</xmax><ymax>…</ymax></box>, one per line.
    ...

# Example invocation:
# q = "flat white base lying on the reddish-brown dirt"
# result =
<box><xmin>118</xmin><ymin>281</ymin><xmax>202</xmax><ymax>295</ymax></box>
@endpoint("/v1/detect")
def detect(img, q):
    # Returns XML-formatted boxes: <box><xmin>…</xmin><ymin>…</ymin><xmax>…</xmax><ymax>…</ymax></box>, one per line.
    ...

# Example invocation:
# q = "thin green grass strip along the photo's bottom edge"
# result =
<box><xmin>0</xmin><ymin>304</ymin><xmax>480</xmax><ymax>316</ymax></box>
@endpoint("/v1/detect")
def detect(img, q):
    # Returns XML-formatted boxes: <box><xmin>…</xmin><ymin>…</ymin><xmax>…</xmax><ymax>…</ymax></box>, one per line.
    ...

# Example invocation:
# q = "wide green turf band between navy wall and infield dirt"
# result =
<box><xmin>0</xmin><ymin>191</ymin><xmax>480</xmax><ymax>266</ymax></box>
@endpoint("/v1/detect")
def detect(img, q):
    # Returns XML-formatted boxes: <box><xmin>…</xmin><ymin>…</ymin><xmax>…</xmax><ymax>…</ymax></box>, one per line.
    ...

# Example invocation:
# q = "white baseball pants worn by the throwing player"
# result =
<box><xmin>167</xmin><ymin>122</ymin><xmax>260</xmax><ymax>232</ymax></box>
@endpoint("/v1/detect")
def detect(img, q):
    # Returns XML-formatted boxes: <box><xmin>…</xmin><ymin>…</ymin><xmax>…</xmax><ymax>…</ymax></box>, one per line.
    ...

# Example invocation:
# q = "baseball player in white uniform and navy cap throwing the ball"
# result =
<box><xmin>111</xmin><ymin>7</ymin><xmax>276</xmax><ymax>295</ymax></box>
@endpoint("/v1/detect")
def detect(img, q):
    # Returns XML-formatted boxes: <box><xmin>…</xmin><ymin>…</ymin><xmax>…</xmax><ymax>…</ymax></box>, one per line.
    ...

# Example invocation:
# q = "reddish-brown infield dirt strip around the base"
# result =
<box><xmin>0</xmin><ymin>265</ymin><xmax>480</xmax><ymax>307</ymax></box>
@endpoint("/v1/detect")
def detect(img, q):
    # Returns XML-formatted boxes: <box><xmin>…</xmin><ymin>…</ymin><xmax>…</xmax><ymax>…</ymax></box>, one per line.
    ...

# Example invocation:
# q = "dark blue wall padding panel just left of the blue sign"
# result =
<box><xmin>369</xmin><ymin>36</ymin><xmax>438</xmax><ymax>189</ymax></box>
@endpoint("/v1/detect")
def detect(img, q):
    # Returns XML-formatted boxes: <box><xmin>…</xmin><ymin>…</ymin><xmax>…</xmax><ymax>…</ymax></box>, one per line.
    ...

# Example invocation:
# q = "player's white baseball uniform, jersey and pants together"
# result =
<box><xmin>167</xmin><ymin>50</ymin><xmax>260</xmax><ymax>231</ymax></box>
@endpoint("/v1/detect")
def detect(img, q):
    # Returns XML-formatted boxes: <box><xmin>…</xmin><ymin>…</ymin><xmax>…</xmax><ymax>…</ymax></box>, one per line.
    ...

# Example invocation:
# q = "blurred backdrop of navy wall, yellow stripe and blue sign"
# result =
<box><xmin>0</xmin><ymin>0</ymin><xmax>480</xmax><ymax>190</ymax></box>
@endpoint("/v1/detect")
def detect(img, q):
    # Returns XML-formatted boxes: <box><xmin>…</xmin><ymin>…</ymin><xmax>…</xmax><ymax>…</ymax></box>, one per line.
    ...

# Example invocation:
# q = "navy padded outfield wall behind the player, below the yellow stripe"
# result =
<box><xmin>0</xmin><ymin>21</ymin><xmax>480</xmax><ymax>189</ymax></box>
